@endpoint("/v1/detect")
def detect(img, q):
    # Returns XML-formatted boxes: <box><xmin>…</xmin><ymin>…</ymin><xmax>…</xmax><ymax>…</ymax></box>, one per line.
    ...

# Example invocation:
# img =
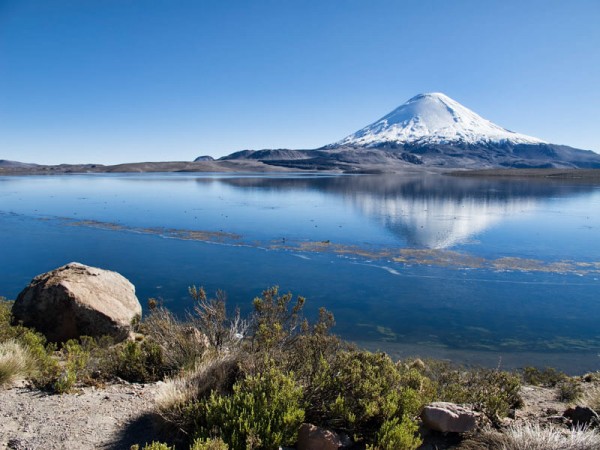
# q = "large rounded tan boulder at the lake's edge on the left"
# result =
<box><xmin>12</xmin><ymin>263</ymin><xmax>142</xmax><ymax>342</ymax></box>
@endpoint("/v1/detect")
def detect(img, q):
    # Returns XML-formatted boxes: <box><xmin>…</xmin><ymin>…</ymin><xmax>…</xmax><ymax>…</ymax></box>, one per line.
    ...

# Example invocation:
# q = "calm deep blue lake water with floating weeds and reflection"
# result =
<box><xmin>0</xmin><ymin>174</ymin><xmax>600</xmax><ymax>373</ymax></box>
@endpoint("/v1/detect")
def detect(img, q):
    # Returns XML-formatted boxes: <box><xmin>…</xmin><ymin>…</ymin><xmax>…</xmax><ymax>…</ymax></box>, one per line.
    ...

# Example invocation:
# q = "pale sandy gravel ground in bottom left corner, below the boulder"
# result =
<box><xmin>0</xmin><ymin>384</ymin><xmax>164</xmax><ymax>450</ymax></box>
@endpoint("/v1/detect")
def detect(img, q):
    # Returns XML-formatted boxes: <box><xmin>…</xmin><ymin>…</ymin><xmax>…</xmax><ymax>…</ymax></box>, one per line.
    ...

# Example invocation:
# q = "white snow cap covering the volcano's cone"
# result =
<box><xmin>334</xmin><ymin>92</ymin><xmax>545</xmax><ymax>147</ymax></box>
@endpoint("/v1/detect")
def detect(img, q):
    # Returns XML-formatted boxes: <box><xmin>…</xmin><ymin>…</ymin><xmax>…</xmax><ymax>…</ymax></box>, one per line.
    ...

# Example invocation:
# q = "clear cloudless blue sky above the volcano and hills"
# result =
<box><xmin>0</xmin><ymin>0</ymin><xmax>600</xmax><ymax>163</ymax></box>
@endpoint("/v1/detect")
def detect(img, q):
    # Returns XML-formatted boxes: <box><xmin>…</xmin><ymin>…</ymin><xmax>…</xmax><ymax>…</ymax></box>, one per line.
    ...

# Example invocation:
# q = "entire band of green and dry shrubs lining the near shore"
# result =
<box><xmin>0</xmin><ymin>287</ymin><xmax>595</xmax><ymax>450</ymax></box>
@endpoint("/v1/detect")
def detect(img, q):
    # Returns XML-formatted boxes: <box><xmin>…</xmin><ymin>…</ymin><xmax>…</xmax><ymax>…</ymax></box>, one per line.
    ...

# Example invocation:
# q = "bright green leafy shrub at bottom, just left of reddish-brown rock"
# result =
<box><xmin>196</xmin><ymin>366</ymin><xmax>304</xmax><ymax>450</ymax></box>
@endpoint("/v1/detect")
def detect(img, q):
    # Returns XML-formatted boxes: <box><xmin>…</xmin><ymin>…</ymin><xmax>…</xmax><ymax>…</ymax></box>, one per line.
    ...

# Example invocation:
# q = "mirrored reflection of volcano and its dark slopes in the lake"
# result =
<box><xmin>213</xmin><ymin>175</ymin><xmax>595</xmax><ymax>249</ymax></box>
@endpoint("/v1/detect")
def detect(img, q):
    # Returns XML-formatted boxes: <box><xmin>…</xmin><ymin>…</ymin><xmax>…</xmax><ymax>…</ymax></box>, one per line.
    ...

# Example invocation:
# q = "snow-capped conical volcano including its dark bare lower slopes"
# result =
<box><xmin>221</xmin><ymin>93</ymin><xmax>600</xmax><ymax>172</ymax></box>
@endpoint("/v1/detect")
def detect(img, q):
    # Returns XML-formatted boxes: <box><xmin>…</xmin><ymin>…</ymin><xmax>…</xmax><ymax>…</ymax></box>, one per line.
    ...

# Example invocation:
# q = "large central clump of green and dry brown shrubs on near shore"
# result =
<box><xmin>158</xmin><ymin>287</ymin><xmax>426</xmax><ymax>450</ymax></box>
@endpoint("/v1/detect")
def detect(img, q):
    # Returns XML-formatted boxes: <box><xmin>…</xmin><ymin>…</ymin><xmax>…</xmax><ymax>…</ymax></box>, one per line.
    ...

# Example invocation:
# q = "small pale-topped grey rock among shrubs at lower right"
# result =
<box><xmin>421</xmin><ymin>402</ymin><xmax>479</xmax><ymax>433</ymax></box>
